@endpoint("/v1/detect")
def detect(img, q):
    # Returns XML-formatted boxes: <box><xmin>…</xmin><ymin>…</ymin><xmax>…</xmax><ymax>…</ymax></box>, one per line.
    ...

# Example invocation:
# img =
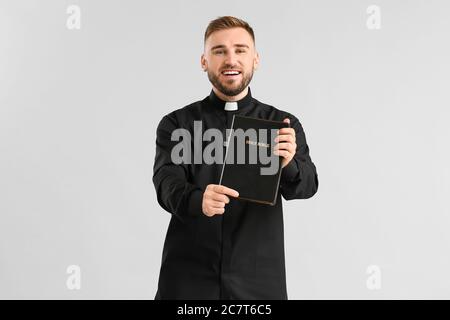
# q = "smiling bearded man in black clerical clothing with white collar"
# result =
<box><xmin>153</xmin><ymin>16</ymin><xmax>318</xmax><ymax>299</ymax></box>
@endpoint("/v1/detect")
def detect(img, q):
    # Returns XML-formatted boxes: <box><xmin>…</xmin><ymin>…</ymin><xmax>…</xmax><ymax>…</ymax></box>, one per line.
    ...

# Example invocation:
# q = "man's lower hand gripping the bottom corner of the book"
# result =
<box><xmin>202</xmin><ymin>184</ymin><xmax>239</xmax><ymax>217</ymax></box>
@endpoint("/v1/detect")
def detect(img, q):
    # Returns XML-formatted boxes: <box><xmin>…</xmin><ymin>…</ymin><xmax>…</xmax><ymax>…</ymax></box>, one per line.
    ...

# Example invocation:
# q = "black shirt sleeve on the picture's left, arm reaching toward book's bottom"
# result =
<box><xmin>153</xmin><ymin>115</ymin><xmax>203</xmax><ymax>219</ymax></box>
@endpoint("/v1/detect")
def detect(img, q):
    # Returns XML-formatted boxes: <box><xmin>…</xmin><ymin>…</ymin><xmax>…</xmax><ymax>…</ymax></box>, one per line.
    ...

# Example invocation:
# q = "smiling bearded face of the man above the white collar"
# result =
<box><xmin>201</xmin><ymin>28</ymin><xmax>259</xmax><ymax>96</ymax></box>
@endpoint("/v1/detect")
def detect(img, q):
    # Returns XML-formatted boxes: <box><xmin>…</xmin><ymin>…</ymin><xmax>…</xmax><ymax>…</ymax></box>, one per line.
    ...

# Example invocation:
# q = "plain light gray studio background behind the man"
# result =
<box><xmin>0</xmin><ymin>0</ymin><xmax>450</xmax><ymax>299</ymax></box>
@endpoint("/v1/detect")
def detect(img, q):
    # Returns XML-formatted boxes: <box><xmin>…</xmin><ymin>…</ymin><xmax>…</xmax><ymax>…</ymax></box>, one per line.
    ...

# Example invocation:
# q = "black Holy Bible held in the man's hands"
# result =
<box><xmin>219</xmin><ymin>115</ymin><xmax>289</xmax><ymax>205</ymax></box>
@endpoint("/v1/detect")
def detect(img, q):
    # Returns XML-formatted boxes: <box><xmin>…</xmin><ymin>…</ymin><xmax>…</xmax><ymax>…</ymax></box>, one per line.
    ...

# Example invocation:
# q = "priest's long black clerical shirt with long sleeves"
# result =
<box><xmin>153</xmin><ymin>88</ymin><xmax>319</xmax><ymax>299</ymax></box>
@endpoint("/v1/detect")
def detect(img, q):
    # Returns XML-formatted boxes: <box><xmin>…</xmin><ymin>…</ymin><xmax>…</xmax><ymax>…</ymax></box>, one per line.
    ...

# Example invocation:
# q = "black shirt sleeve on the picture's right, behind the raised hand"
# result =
<box><xmin>280</xmin><ymin>115</ymin><xmax>319</xmax><ymax>200</ymax></box>
